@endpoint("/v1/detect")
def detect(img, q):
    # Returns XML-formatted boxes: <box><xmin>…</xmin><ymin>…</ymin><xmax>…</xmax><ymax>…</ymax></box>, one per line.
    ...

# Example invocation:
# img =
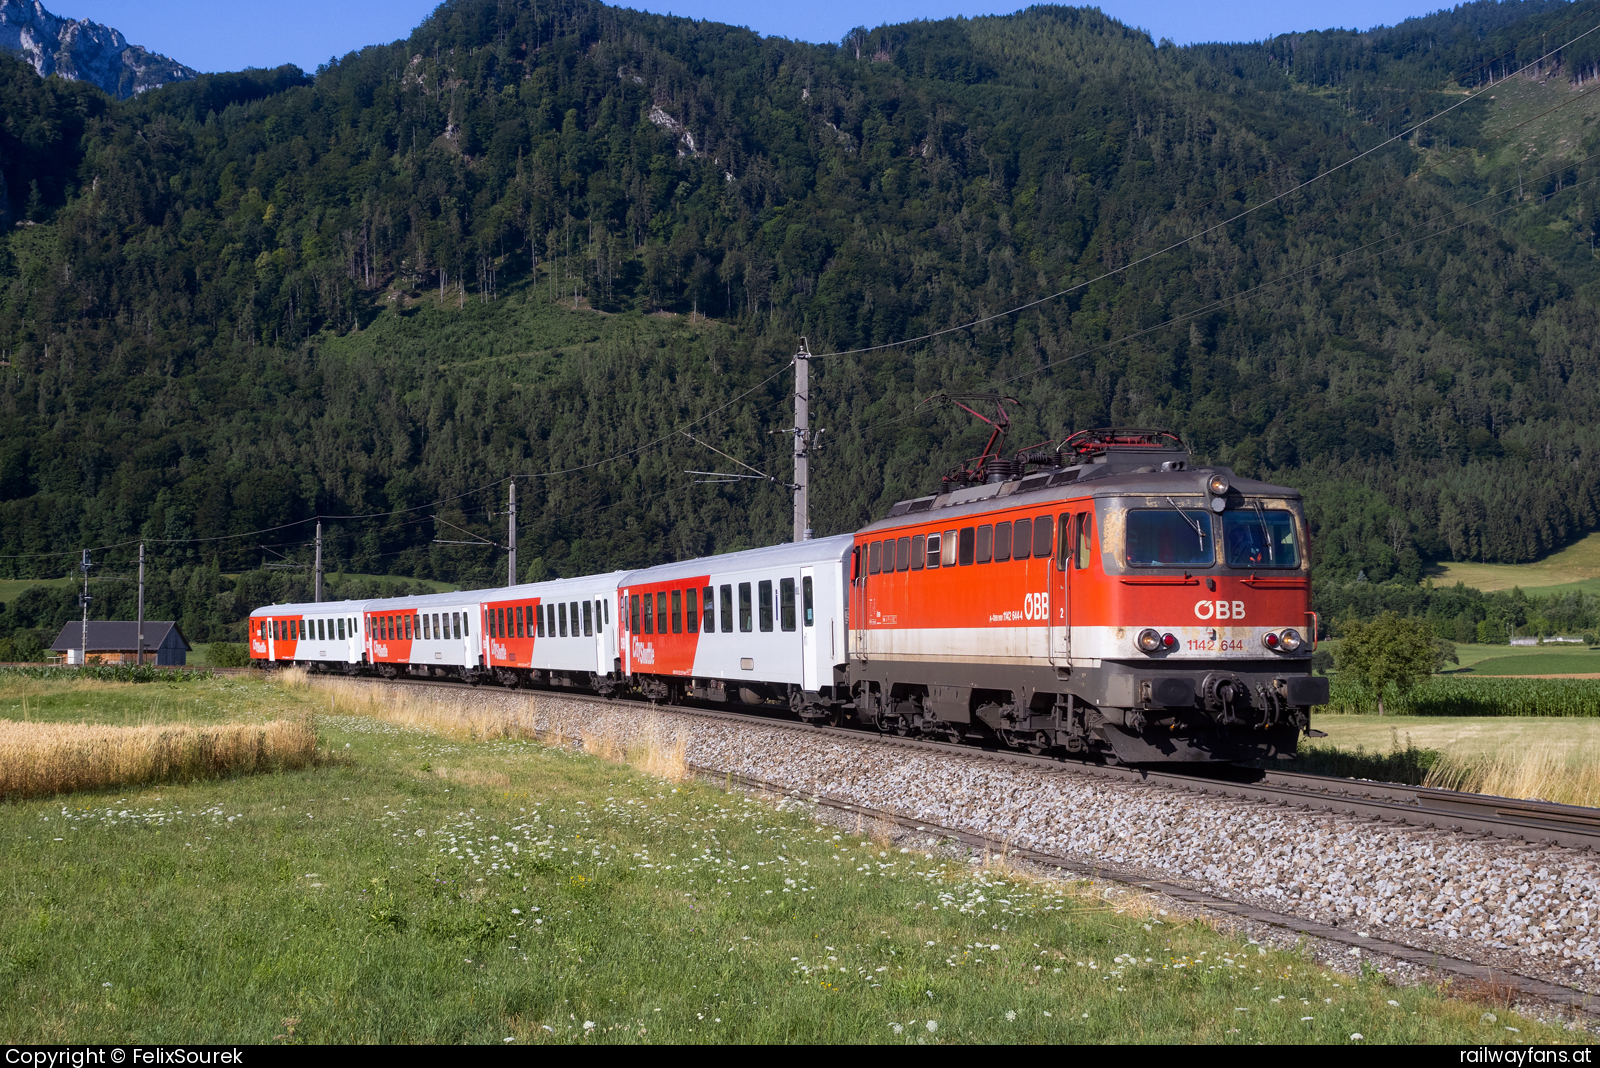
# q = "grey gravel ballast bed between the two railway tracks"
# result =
<box><xmin>366</xmin><ymin>689</ymin><xmax>1600</xmax><ymax>993</ymax></box>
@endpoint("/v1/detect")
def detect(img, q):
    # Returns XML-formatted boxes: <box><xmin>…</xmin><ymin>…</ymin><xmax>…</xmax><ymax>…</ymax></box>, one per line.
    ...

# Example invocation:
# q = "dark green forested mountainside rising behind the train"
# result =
<box><xmin>0</xmin><ymin>0</ymin><xmax>1600</xmax><ymax>639</ymax></box>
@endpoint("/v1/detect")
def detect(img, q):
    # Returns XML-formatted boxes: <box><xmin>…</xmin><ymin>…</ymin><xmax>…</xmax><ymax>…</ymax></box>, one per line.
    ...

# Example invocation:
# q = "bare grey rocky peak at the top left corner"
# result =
<box><xmin>0</xmin><ymin>0</ymin><xmax>195</xmax><ymax>99</ymax></box>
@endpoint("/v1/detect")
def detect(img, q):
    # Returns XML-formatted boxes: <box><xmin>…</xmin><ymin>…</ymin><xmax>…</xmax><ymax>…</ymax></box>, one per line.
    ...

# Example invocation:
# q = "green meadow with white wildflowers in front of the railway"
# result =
<box><xmin>0</xmin><ymin>678</ymin><xmax>1571</xmax><ymax>1044</ymax></box>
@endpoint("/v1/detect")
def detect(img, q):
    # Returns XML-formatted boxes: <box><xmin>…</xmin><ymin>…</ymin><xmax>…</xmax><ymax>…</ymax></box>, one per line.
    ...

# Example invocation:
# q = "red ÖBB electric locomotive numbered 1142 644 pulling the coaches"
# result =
<box><xmin>846</xmin><ymin>422</ymin><xmax>1328</xmax><ymax>764</ymax></box>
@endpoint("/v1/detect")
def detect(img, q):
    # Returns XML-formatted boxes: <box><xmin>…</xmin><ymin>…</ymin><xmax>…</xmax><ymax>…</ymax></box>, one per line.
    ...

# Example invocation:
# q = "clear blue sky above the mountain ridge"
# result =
<box><xmin>72</xmin><ymin>0</ymin><xmax>1472</xmax><ymax>70</ymax></box>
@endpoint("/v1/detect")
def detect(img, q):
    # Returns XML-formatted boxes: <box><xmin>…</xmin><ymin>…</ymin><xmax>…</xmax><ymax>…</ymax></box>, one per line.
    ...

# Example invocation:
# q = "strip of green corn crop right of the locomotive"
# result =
<box><xmin>1317</xmin><ymin>675</ymin><xmax>1600</xmax><ymax>716</ymax></box>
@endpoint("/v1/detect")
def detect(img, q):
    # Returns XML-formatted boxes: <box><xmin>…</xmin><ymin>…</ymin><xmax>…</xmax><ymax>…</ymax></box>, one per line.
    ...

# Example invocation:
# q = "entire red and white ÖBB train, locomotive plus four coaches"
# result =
<box><xmin>250</xmin><ymin>430</ymin><xmax>1328</xmax><ymax>763</ymax></box>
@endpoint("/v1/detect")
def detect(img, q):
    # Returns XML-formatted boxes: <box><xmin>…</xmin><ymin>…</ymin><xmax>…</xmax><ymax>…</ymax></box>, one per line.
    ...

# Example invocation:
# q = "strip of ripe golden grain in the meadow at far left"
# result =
<box><xmin>0</xmin><ymin>718</ymin><xmax>317</xmax><ymax>798</ymax></box>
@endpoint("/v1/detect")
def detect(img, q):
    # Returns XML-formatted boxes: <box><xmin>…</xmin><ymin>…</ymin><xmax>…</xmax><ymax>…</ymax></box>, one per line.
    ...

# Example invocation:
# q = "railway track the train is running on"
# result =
<box><xmin>314</xmin><ymin>676</ymin><xmax>1600</xmax><ymax>849</ymax></box>
